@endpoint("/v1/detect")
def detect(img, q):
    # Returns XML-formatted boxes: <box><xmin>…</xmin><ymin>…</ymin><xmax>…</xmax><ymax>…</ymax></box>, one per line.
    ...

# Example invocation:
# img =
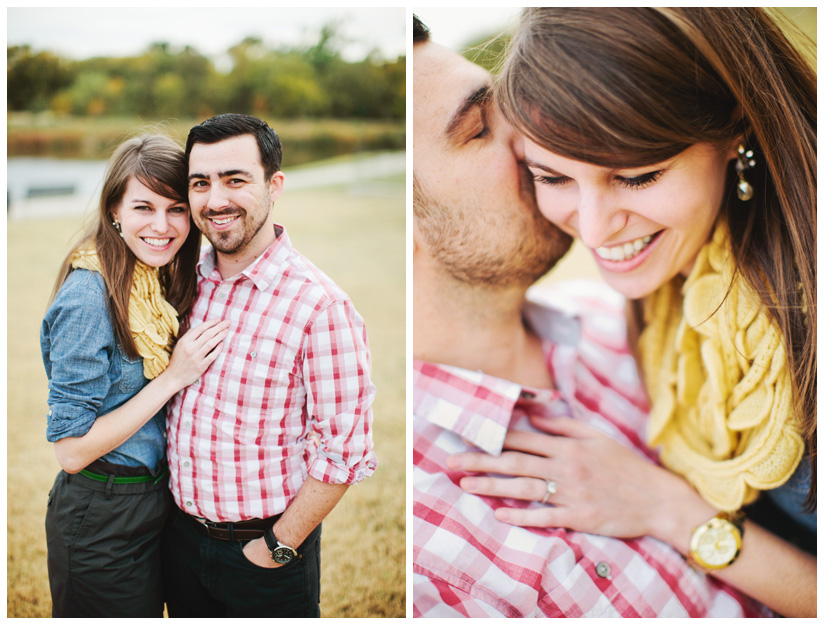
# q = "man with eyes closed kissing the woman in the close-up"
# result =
<box><xmin>413</xmin><ymin>18</ymin><xmax>762</xmax><ymax>617</ymax></box>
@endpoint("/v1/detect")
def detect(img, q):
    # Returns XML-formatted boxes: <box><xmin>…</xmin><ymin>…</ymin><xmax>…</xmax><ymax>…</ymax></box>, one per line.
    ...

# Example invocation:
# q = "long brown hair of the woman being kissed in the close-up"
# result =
<box><xmin>496</xmin><ymin>7</ymin><xmax>816</xmax><ymax>509</ymax></box>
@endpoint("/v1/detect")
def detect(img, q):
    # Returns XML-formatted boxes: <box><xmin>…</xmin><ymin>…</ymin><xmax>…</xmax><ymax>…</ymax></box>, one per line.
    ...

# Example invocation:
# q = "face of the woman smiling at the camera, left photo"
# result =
<box><xmin>113</xmin><ymin>176</ymin><xmax>189</xmax><ymax>267</ymax></box>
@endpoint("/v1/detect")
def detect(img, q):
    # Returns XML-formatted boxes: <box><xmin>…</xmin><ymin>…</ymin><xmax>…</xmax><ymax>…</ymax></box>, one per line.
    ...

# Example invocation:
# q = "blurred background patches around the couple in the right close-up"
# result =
<box><xmin>413</xmin><ymin>7</ymin><xmax>816</xmax><ymax>284</ymax></box>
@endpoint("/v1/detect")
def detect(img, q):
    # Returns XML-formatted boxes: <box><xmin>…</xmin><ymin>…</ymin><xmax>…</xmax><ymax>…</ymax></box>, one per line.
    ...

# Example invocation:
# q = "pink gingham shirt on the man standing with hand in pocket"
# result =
<box><xmin>167</xmin><ymin>226</ymin><xmax>377</xmax><ymax>522</ymax></box>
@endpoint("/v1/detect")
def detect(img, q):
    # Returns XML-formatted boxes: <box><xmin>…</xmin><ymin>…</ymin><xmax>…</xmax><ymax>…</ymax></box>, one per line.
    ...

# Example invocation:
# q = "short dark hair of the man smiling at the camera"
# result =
<box><xmin>185</xmin><ymin>113</ymin><xmax>282</xmax><ymax>180</ymax></box>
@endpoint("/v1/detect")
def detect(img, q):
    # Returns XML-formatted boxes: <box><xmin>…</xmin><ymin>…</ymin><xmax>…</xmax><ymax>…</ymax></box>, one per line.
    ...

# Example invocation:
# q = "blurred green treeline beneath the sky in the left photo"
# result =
<box><xmin>8</xmin><ymin>23</ymin><xmax>406</xmax><ymax>120</ymax></box>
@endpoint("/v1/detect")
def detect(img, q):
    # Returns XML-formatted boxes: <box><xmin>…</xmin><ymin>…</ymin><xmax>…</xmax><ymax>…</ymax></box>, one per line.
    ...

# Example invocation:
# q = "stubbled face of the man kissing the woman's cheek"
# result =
<box><xmin>413</xmin><ymin>42</ymin><xmax>571</xmax><ymax>286</ymax></box>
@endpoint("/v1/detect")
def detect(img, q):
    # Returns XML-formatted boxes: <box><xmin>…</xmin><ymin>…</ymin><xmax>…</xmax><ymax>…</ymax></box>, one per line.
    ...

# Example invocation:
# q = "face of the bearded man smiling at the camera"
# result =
<box><xmin>189</xmin><ymin>135</ymin><xmax>283</xmax><ymax>256</ymax></box>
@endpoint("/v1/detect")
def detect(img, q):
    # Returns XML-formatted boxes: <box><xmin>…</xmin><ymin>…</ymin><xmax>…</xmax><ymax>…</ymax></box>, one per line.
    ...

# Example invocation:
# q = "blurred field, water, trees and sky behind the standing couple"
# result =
<box><xmin>6</xmin><ymin>8</ymin><xmax>406</xmax><ymax>617</ymax></box>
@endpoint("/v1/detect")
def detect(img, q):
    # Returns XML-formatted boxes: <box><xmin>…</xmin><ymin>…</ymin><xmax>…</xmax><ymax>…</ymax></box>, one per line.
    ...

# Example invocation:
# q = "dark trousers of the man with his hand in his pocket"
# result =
<box><xmin>163</xmin><ymin>507</ymin><xmax>321</xmax><ymax>617</ymax></box>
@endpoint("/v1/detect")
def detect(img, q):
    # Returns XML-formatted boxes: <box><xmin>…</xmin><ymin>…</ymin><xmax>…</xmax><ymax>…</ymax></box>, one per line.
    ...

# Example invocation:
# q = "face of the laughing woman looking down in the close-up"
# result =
<box><xmin>525</xmin><ymin>140</ymin><xmax>736</xmax><ymax>298</ymax></box>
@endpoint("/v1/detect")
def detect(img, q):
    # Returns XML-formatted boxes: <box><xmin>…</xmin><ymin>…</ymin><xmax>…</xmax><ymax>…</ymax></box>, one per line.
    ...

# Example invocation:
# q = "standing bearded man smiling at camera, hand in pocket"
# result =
<box><xmin>164</xmin><ymin>114</ymin><xmax>376</xmax><ymax>617</ymax></box>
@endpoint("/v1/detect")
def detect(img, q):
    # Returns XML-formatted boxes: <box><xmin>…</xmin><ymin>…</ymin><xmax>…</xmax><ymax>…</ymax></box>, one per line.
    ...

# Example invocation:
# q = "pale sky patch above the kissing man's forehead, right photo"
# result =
<box><xmin>413</xmin><ymin>7</ymin><xmax>519</xmax><ymax>52</ymax></box>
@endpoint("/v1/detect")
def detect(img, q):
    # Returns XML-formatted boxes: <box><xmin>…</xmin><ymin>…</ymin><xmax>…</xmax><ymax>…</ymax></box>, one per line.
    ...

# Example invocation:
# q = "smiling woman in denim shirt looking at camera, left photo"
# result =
<box><xmin>40</xmin><ymin>135</ymin><xmax>228</xmax><ymax>617</ymax></box>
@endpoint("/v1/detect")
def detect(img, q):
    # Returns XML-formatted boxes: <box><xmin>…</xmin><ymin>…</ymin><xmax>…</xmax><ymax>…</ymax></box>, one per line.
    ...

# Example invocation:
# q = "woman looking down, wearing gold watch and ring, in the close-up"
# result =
<box><xmin>454</xmin><ymin>8</ymin><xmax>816</xmax><ymax>616</ymax></box>
